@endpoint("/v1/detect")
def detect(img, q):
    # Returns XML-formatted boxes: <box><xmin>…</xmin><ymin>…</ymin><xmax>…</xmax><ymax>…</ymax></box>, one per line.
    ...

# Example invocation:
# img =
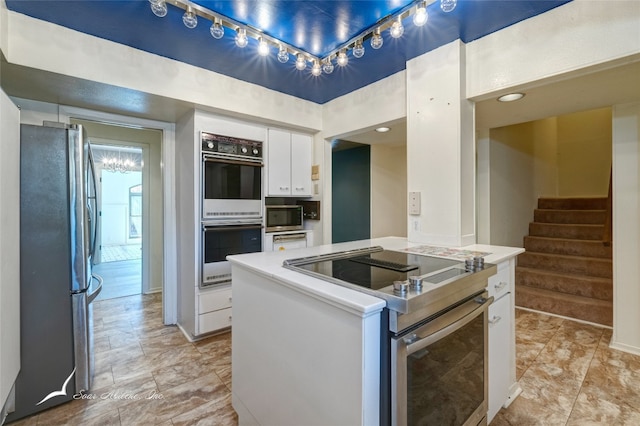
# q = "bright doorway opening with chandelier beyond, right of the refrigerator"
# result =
<box><xmin>92</xmin><ymin>143</ymin><xmax>143</xmax><ymax>300</ymax></box>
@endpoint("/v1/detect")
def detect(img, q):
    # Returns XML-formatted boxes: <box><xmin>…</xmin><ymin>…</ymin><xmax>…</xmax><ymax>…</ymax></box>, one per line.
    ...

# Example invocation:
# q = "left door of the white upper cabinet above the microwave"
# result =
<box><xmin>267</xmin><ymin>129</ymin><xmax>291</xmax><ymax>196</ymax></box>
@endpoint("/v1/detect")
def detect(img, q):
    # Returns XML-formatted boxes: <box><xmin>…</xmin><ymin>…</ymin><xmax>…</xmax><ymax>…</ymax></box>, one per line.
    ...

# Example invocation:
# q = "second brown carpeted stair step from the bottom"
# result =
<box><xmin>516</xmin><ymin>266</ymin><xmax>613</xmax><ymax>301</ymax></box>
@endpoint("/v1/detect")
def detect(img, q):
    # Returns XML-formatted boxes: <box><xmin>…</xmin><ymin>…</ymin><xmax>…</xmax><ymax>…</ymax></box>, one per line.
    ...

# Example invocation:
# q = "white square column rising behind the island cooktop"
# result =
<box><xmin>407</xmin><ymin>40</ymin><xmax>476</xmax><ymax>246</ymax></box>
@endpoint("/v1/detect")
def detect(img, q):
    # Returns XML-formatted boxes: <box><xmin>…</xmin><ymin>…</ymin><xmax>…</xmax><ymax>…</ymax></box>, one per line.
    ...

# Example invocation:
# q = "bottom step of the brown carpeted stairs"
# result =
<box><xmin>515</xmin><ymin>285</ymin><xmax>613</xmax><ymax>326</ymax></box>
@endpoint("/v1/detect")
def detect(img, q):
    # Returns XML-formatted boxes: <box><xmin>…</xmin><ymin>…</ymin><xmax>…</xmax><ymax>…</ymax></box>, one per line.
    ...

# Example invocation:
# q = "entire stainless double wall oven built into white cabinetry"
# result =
<box><xmin>200</xmin><ymin>132</ymin><xmax>263</xmax><ymax>287</ymax></box>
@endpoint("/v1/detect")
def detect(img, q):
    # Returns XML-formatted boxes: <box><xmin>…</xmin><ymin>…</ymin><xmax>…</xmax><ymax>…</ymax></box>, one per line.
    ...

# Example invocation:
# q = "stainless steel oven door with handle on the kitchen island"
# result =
<box><xmin>391</xmin><ymin>292</ymin><xmax>493</xmax><ymax>426</ymax></box>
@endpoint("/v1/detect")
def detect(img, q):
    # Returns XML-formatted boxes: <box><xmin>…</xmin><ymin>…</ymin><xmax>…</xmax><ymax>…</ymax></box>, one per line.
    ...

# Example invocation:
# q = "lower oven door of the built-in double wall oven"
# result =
<box><xmin>200</xmin><ymin>223</ymin><xmax>262</xmax><ymax>287</ymax></box>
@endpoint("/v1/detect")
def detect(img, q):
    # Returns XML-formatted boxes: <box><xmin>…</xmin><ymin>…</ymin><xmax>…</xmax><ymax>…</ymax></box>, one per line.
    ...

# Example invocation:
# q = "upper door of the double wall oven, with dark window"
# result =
<box><xmin>202</xmin><ymin>154</ymin><xmax>262</xmax><ymax>220</ymax></box>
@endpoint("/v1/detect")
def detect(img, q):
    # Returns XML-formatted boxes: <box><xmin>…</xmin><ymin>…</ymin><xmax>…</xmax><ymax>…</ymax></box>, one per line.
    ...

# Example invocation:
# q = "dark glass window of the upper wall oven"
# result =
<box><xmin>204</xmin><ymin>159</ymin><xmax>262</xmax><ymax>200</ymax></box>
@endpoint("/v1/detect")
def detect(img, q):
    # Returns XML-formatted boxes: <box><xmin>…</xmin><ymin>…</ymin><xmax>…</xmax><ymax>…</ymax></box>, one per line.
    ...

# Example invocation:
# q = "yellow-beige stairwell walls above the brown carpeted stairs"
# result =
<box><xmin>488</xmin><ymin>108</ymin><xmax>611</xmax><ymax>247</ymax></box>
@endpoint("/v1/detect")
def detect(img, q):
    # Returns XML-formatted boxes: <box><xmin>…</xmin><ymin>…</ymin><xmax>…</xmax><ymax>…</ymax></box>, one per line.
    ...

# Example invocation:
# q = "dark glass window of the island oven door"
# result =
<box><xmin>407</xmin><ymin>315</ymin><xmax>484</xmax><ymax>425</ymax></box>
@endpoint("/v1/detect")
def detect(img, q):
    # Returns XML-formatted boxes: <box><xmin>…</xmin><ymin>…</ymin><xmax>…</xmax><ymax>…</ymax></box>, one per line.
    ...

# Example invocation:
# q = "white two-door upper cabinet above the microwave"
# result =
<box><xmin>266</xmin><ymin>129</ymin><xmax>313</xmax><ymax>197</ymax></box>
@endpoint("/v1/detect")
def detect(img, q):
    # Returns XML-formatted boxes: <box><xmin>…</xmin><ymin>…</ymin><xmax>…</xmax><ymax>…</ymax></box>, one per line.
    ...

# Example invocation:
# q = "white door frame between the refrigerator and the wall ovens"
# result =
<box><xmin>59</xmin><ymin>105</ymin><xmax>178</xmax><ymax>325</ymax></box>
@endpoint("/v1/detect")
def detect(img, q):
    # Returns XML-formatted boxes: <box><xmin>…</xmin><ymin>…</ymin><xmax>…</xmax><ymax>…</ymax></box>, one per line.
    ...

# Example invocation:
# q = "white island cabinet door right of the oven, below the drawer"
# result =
<box><xmin>487</xmin><ymin>293</ymin><xmax>515</xmax><ymax>422</ymax></box>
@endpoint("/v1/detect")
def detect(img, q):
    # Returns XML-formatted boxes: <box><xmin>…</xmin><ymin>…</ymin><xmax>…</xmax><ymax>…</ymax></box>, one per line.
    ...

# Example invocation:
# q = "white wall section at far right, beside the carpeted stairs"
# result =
<box><xmin>611</xmin><ymin>103</ymin><xmax>640</xmax><ymax>355</ymax></box>
